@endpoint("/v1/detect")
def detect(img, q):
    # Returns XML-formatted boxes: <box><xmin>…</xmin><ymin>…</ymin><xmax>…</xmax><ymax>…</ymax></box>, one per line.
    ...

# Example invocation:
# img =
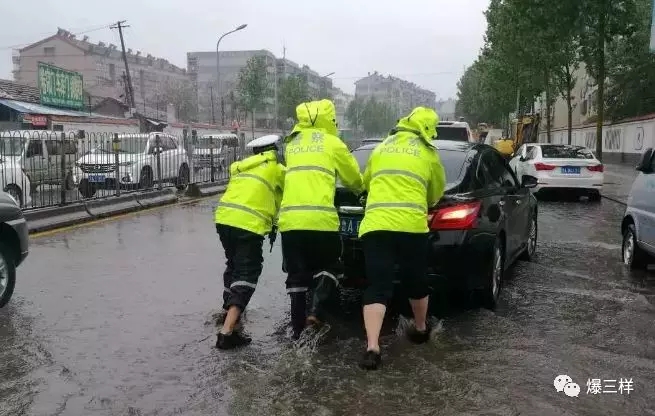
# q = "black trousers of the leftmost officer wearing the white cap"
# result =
<box><xmin>216</xmin><ymin>224</ymin><xmax>264</xmax><ymax>311</ymax></box>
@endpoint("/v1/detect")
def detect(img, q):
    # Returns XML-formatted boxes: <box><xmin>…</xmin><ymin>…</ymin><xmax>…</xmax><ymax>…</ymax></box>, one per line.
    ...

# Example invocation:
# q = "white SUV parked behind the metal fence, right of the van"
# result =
<box><xmin>75</xmin><ymin>133</ymin><xmax>190</xmax><ymax>198</ymax></box>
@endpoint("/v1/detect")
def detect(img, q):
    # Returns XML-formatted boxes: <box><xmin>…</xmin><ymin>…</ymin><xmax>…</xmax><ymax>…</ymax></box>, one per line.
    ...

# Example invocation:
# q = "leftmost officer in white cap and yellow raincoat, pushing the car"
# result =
<box><xmin>215</xmin><ymin>135</ymin><xmax>285</xmax><ymax>349</ymax></box>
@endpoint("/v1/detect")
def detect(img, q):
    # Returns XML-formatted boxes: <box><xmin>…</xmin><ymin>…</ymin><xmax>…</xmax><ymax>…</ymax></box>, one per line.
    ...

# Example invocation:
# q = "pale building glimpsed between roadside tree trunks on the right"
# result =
<box><xmin>535</xmin><ymin>63</ymin><xmax>598</xmax><ymax>129</ymax></box>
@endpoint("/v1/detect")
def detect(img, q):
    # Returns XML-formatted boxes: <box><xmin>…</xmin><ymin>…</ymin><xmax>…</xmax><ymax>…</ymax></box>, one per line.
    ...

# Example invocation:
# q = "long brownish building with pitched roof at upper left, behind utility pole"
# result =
<box><xmin>13</xmin><ymin>28</ymin><xmax>189</xmax><ymax>119</ymax></box>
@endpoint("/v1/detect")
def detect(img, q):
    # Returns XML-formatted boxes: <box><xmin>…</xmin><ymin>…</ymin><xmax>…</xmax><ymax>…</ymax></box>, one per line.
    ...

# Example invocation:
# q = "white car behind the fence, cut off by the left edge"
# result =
<box><xmin>0</xmin><ymin>144</ymin><xmax>32</xmax><ymax>208</ymax></box>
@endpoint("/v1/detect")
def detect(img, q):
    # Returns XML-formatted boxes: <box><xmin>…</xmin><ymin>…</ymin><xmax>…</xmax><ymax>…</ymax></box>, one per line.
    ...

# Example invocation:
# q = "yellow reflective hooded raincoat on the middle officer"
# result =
<box><xmin>278</xmin><ymin>100</ymin><xmax>364</xmax><ymax>232</ymax></box>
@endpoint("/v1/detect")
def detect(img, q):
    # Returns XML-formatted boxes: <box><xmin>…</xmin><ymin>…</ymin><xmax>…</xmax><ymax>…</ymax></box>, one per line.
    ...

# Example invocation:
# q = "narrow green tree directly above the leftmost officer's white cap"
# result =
<box><xmin>236</xmin><ymin>56</ymin><xmax>270</xmax><ymax>135</ymax></box>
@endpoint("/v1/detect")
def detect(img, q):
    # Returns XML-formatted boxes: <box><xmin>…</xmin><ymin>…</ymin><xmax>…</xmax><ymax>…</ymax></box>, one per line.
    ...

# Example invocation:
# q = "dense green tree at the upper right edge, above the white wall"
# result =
<box><xmin>605</xmin><ymin>0</ymin><xmax>655</xmax><ymax>121</ymax></box>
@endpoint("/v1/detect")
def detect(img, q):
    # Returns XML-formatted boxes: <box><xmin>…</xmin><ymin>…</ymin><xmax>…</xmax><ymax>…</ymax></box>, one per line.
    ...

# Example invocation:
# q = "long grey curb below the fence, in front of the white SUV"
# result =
<box><xmin>24</xmin><ymin>188</ymin><xmax>178</xmax><ymax>234</ymax></box>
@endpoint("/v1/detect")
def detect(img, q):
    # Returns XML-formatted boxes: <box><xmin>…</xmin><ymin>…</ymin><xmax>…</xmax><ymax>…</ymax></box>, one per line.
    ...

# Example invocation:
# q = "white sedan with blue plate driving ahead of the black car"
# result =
<box><xmin>509</xmin><ymin>143</ymin><xmax>604</xmax><ymax>201</ymax></box>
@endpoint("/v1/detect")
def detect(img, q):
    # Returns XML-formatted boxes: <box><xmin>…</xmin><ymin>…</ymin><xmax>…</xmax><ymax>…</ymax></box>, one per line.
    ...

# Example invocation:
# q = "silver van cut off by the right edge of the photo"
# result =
<box><xmin>621</xmin><ymin>148</ymin><xmax>655</xmax><ymax>269</ymax></box>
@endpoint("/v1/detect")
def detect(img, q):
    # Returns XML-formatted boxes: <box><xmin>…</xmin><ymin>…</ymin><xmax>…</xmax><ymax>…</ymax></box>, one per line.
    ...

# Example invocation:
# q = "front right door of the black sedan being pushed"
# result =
<box><xmin>489</xmin><ymin>152</ymin><xmax>529</xmax><ymax>260</ymax></box>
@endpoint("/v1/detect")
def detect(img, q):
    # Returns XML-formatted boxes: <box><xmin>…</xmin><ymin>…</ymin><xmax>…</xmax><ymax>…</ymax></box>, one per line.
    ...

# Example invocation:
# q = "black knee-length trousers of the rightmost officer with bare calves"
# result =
<box><xmin>362</xmin><ymin>231</ymin><xmax>430</xmax><ymax>305</ymax></box>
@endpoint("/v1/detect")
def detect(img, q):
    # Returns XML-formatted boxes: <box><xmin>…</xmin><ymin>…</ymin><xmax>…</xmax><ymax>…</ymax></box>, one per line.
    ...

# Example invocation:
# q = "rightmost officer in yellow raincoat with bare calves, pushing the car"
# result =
<box><xmin>359</xmin><ymin>107</ymin><xmax>446</xmax><ymax>370</ymax></box>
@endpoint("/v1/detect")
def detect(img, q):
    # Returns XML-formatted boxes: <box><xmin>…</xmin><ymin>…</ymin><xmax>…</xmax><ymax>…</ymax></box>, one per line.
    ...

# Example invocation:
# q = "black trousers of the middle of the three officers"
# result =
<box><xmin>281</xmin><ymin>231</ymin><xmax>342</xmax><ymax>293</ymax></box>
